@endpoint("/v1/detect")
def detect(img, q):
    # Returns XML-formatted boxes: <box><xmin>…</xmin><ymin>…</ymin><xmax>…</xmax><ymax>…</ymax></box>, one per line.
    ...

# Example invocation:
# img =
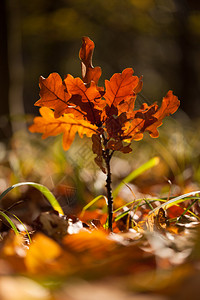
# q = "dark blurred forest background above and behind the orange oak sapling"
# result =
<box><xmin>0</xmin><ymin>0</ymin><xmax>200</xmax><ymax>139</ymax></box>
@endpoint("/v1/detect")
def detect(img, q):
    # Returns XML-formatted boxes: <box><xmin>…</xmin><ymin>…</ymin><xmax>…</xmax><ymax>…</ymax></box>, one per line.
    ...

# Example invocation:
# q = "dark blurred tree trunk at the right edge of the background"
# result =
<box><xmin>176</xmin><ymin>0</ymin><xmax>200</xmax><ymax>117</ymax></box>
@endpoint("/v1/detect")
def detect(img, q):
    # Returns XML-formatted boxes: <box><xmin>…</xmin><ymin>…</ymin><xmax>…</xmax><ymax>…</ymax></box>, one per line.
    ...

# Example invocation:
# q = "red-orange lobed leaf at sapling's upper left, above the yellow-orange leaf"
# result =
<box><xmin>35</xmin><ymin>73</ymin><xmax>71</xmax><ymax>118</ymax></box>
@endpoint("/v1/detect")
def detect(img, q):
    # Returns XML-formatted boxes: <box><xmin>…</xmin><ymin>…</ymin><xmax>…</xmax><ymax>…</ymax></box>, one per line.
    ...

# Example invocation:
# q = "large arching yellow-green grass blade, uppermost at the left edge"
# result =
<box><xmin>0</xmin><ymin>182</ymin><xmax>64</xmax><ymax>215</ymax></box>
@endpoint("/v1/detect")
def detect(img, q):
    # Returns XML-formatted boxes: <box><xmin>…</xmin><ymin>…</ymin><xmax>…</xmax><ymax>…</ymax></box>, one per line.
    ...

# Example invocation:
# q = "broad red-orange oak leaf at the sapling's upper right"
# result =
<box><xmin>104</xmin><ymin>68</ymin><xmax>139</xmax><ymax>106</ymax></box>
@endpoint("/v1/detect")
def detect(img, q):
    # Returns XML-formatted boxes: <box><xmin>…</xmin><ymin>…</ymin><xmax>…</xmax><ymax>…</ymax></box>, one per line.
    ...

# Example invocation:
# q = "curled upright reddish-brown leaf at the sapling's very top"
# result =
<box><xmin>79</xmin><ymin>36</ymin><xmax>101</xmax><ymax>84</ymax></box>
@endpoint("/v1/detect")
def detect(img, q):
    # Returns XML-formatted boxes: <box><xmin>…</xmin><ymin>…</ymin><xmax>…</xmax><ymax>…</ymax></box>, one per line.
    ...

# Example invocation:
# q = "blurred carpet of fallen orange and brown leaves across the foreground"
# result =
<box><xmin>0</xmin><ymin>196</ymin><xmax>200</xmax><ymax>299</ymax></box>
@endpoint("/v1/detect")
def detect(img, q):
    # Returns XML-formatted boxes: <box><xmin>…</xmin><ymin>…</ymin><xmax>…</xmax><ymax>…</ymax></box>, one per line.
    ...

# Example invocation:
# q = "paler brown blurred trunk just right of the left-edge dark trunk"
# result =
<box><xmin>6</xmin><ymin>0</ymin><xmax>26</xmax><ymax>133</ymax></box>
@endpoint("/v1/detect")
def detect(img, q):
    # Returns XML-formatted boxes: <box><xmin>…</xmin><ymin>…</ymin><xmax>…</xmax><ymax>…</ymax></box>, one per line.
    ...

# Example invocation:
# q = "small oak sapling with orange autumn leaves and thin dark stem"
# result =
<box><xmin>29</xmin><ymin>37</ymin><xmax>180</xmax><ymax>231</ymax></box>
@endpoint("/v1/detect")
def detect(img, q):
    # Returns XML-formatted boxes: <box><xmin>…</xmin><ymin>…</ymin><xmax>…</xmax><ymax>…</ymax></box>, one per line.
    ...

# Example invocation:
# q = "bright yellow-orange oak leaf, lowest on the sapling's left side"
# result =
<box><xmin>29</xmin><ymin>107</ymin><xmax>97</xmax><ymax>150</ymax></box>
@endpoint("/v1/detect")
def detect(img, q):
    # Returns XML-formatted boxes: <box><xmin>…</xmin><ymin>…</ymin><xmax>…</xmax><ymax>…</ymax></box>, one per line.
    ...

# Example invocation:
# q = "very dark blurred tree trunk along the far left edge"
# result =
<box><xmin>0</xmin><ymin>0</ymin><xmax>11</xmax><ymax>140</ymax></box>
